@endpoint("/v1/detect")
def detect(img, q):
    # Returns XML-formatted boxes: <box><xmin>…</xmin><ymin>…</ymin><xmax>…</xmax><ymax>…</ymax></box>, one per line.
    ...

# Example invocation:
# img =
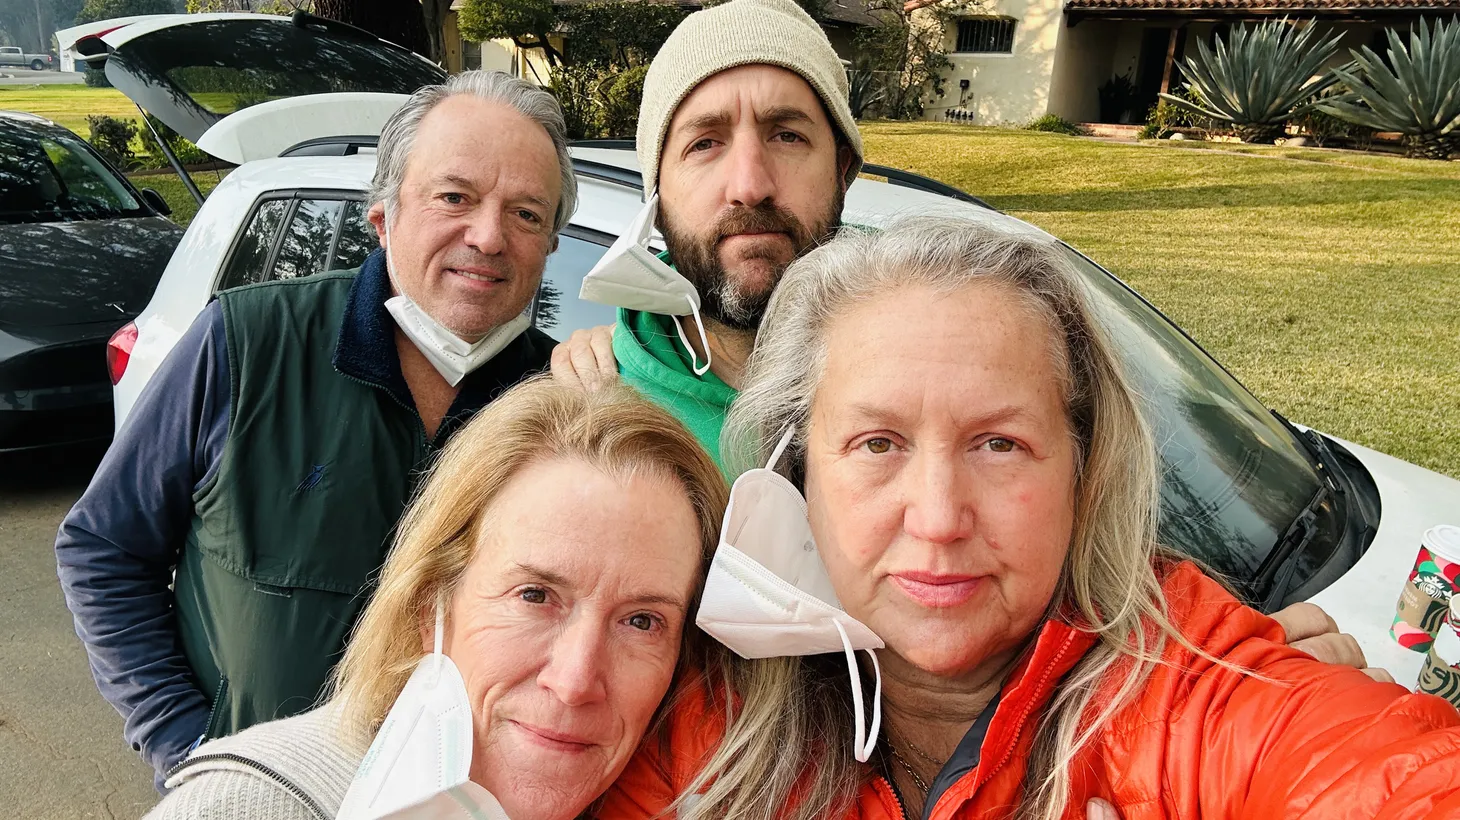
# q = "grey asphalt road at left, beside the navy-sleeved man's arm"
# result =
<box><xmin>0</xmin><ymin>443</ymin><xmax>156</xmax><ymax>820</ymax></box>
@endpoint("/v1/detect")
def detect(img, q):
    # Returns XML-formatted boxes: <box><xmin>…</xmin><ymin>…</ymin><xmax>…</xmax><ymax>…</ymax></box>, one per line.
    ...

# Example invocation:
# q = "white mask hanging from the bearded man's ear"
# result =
<box><xmin>578</xmin><ymin>193</ymin><xmax>710</xmax><ymax>376</ymax></box>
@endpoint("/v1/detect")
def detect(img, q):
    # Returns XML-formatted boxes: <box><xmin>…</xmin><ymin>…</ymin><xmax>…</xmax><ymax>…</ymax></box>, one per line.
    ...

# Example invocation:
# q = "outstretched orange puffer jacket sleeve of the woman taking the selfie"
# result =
<box><xmin>1126</xmin><ymin>573</ymin><xmax>1460</xmax><ymax>820</ymax></box>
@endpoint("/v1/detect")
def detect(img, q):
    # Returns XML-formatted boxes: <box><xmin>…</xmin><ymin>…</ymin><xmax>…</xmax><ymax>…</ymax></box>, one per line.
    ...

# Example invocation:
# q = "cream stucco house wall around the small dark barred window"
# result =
<box><xmin>923</xmin><ymin>0</ymin><xmax>1064</xmax><ymax>125</ymax></box>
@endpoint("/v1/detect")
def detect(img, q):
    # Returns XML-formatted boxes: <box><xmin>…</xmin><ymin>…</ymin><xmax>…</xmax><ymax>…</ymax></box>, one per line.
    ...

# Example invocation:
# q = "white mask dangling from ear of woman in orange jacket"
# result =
<box><xmin>695</xmin><ymin>429</ymin><xmax>883</xmax><ymax>763</ymax></box>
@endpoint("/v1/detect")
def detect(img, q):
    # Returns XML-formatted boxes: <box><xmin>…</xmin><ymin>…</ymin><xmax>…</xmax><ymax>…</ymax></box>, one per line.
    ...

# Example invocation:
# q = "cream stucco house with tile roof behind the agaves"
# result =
<box><xmin>908</xmin><ymin>0</ymin><xmax>1460</xmax><ymax>125</ymax></box>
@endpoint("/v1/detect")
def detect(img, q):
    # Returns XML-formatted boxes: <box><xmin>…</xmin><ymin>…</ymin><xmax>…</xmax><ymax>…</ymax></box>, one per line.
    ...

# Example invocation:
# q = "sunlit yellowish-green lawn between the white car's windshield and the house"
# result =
<box><xmin>863</xmin><ymin>123</ymin><xmax>1460</xmax><ymax>477</ymax></box>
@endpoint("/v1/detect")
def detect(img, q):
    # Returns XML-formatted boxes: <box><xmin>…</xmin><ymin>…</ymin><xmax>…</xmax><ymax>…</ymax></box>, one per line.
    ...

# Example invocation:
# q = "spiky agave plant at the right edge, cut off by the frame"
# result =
<box><xmin>1317</xmin><ymin>20</ymin><xmax>1460</xmax><ymax>159</ymax></box>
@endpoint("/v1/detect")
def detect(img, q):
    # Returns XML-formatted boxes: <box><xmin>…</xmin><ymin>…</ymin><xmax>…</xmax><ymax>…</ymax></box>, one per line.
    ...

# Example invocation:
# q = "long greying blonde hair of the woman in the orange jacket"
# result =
<box><xmin>689</xmin><ymin>217</ymin><xmax>1188</xmax><ymax>820</ymax></box>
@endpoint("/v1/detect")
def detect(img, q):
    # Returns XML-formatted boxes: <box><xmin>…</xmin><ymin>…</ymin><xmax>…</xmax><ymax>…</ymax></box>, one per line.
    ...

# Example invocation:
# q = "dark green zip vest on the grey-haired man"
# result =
<box><xmin>175</xmin><ymin>271</ymin><xmax>549</xmax><ymax>738</ymax></box>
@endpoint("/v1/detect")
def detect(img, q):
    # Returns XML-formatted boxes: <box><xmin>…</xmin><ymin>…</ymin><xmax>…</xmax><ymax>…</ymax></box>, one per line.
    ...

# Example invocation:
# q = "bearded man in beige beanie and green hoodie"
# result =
<box><xmin>553</xmin><ymin>0</ymin><xmax>861</xmax><ymax>460</ymax></box>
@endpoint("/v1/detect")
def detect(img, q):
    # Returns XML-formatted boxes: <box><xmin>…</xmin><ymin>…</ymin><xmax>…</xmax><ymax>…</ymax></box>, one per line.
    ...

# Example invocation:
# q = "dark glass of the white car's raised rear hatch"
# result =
<box><xmin>107</xmin><ymin>18</ymin><xmax>445</xmax><ymax>142</ymax></box>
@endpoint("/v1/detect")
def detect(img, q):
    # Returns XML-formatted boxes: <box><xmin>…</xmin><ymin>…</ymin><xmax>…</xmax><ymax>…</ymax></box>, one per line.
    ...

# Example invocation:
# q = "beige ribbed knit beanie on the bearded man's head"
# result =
<box><xmin>638</xmin><ymin>0</ymin><xmax>861</xmax><ymax>198</ymax></box>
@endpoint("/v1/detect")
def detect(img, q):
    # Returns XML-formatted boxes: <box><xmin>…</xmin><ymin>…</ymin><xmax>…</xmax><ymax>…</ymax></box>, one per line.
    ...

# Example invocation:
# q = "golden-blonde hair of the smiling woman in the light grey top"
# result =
<box><xmin>333</xmin><ymin>376</ymin><xmax>727</xmax><ymax>732</ymax></box>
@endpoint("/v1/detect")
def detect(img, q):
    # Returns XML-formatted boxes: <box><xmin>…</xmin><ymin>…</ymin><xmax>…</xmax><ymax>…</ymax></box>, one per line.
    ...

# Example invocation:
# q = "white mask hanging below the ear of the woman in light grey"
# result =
<box><xmin>337</xmin><ymin>600</ymin><xmax>508</xmax><ymax>820</ymax></box>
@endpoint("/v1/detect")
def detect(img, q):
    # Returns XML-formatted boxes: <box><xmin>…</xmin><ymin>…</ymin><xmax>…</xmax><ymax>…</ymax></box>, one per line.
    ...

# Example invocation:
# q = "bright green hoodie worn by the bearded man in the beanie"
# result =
<box><xmin>613</xmin><ymin>308</ymin><xmax>736</xmax><ymax>471</ymax></box>
